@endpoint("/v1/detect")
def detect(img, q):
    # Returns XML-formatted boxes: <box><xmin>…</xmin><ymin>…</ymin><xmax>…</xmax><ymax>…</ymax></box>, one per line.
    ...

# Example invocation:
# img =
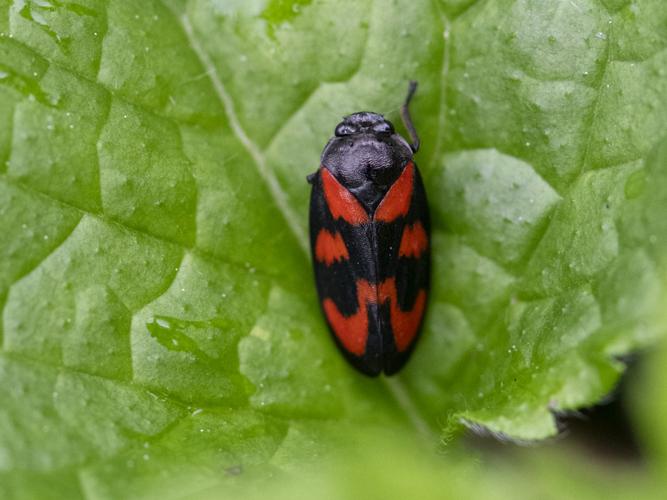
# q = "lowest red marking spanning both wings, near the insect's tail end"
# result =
<box><xmin>322</xmin><ymin>278</ymin><xmax>426</xmax><ymax>356</ymax></box>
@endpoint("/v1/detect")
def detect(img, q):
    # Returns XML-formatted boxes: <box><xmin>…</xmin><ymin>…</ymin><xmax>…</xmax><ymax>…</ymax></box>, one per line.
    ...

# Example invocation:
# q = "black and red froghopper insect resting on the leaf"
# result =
<box><xmin>308</xmin><ymin>82</ymin><xmax>430</xmax><ymax>376</ymax></box>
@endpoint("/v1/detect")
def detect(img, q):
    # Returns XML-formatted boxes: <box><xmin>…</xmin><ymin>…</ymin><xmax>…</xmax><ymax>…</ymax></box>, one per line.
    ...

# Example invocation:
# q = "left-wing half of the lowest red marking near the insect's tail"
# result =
<box><xmin>322</xmin><ymin>280</ymin><xmax>377</xmax><ymax>356</ymax></box>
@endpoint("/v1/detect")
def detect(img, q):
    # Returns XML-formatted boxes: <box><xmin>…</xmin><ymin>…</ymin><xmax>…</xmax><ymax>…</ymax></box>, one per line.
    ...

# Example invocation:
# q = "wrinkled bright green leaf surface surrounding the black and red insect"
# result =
<box><xmin>0</xmin><ymin>0</ymin><xmax>667</xmax><ymax>498</ymax></box>
